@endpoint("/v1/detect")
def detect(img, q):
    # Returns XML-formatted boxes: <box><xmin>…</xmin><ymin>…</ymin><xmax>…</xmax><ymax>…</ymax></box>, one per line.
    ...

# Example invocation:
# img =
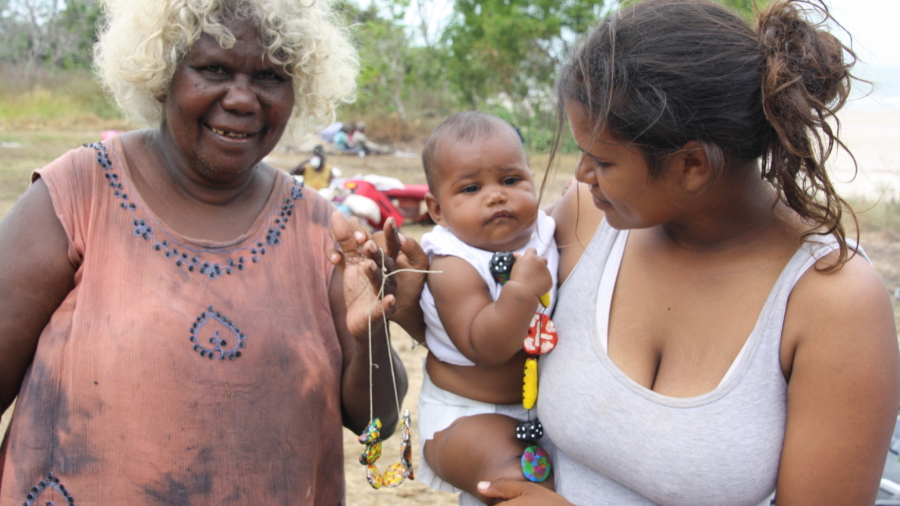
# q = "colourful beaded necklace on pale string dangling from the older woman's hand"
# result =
<box><xmin>359</xmin><ymin>248</ymin><xmax>432</xmax><ymax>489</ymax></box>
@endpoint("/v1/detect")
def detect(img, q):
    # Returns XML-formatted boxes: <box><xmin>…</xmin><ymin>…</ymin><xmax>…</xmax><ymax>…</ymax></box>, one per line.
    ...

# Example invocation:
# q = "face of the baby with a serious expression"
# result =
<box><xmin>428</xmin><ymin>128</ymin><xmax>538</xmax><ymax>252</ymax></box>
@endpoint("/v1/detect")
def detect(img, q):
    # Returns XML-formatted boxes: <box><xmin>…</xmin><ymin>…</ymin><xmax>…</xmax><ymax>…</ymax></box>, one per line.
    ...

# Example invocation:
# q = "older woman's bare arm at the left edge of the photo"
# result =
<box><xmin>0</xmin><ymin>179</ymin><xmax>75</xmax><ymax>411</ymax></box>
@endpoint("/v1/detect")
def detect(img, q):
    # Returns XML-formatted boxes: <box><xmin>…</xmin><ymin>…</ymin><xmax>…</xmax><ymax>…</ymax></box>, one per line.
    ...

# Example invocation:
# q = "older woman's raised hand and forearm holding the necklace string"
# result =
<box><xmin>330</xmin><ymin>212</ymin><xmax>421</xmax><ymax>437</ymax></box>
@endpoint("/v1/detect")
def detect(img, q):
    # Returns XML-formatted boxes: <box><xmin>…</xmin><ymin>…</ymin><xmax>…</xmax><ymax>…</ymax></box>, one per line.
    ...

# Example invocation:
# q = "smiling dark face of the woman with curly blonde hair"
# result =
<box><xmin>162</xmin><ymin>20</ymin><xmax>294</xmax><ymax>182</ymax></box>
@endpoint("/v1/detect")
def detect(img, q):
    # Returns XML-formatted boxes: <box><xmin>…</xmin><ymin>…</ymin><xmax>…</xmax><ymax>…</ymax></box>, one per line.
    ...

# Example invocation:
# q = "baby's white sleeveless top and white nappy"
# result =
<box><xmin>416</xmin><ymin>211</ymin><xmax>559</xmax><ymax>506</ymax></box>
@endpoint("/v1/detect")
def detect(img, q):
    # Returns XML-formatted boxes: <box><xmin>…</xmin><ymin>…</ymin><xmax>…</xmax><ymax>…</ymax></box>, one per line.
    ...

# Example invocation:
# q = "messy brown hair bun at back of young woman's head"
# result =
<box><xmin>757</xmin><ymin>0</ymin><xmax>856</xmax><ymax>106</ymax></box>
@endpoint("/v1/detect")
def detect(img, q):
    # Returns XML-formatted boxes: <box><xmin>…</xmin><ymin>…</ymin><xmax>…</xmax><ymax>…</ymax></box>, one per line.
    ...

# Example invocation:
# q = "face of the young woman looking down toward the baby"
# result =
<box><xmin>566</xmin><ymin>102</ymin><xmax>678</xmax><ymax>229</ymax></box>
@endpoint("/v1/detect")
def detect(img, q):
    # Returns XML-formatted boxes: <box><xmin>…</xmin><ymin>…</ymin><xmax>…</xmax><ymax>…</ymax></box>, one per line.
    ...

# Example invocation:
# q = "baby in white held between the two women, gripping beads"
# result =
<box><xmin>418</xmin><ymin>112</ymin><xmax>559</xmax><ymax>505</ymax></box>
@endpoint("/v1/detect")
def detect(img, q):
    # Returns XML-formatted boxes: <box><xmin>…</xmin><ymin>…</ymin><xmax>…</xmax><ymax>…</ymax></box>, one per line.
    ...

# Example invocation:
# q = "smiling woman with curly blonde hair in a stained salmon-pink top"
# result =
<box><xmin>0</xmin><ymin>0</ymin><xmax>426</xmax><ymax>505</ymax></box>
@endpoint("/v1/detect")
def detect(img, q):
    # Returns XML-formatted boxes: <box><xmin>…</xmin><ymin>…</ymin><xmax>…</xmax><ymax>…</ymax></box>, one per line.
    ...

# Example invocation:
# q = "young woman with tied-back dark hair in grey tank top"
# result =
<box><xmin>479</xmin><ymin>0</ymin><xmax>900</xmax><ymax>506</ymax></box>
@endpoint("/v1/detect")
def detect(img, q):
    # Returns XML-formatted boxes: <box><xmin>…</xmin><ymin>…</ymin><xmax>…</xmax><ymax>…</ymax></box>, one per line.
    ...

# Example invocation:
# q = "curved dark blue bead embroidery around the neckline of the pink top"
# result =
<box><xmin>84</xmin><ymin>142</ymin><xmax>304</xmax><ymax>280</ymax></box>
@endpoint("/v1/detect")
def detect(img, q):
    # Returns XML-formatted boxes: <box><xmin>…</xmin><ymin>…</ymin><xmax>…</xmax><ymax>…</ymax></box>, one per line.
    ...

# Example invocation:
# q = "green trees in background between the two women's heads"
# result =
<box><xmin>338</xmin><ymin>0</ymin><xmax>767</xmax><ymax>150</ymax></box>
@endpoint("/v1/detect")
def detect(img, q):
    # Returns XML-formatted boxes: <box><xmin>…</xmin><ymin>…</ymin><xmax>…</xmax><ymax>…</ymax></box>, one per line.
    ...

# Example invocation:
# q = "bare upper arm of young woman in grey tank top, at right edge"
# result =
<box><xmin>776</xmin><ymin>256</ymin><xmax>900</xmax><ymax>505</ymax></box>
